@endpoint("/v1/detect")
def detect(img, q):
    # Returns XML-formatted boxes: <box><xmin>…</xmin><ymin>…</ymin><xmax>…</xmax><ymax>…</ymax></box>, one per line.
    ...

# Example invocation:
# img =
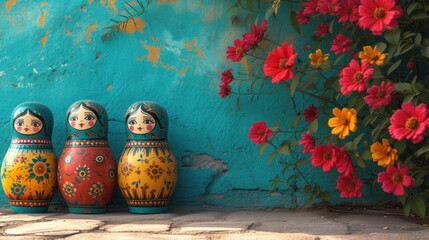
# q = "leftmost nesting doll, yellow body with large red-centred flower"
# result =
<box><xmin>1</xmin><ymin>102</ymin><xmax>57</xmax><ymax>213</ymax></box>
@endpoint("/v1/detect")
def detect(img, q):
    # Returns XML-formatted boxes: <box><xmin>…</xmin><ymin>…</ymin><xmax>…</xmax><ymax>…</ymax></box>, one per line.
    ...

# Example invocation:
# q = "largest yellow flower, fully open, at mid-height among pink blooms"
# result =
<box><xmin>328</xmin><ymin>108</ymin><xmax>357</xmax><ymax>139</ymax></box>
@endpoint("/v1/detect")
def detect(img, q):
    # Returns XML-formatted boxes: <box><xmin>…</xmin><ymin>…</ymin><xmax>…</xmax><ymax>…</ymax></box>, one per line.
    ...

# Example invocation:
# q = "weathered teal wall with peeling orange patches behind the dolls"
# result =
<box><xmin>0</xmin><ymin>0</ymin><xmax>386</xmax><ymax>208</ymax></box>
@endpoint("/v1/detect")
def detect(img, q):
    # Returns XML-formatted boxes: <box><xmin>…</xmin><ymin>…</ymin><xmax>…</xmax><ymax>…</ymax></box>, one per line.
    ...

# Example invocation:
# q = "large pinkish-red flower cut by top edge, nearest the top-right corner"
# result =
<box><xmin>359</xmin><ymin>0</ymin><xmax>402</xmax><ymax>35</ymax></box>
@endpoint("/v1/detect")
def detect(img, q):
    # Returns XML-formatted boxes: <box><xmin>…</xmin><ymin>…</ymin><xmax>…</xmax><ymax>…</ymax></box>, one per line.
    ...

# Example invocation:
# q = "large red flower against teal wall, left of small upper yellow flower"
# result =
<box><xmin>264</xmin><ymin>43</ymin><xmax>298</xmax><ymax>83</ymax></box>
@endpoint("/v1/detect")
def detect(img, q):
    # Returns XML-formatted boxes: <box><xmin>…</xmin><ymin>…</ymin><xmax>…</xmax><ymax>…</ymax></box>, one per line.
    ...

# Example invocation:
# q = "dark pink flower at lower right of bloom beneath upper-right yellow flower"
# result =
<box><xmin>363</xmin><ymin>81</ymin><xmax>395</xmax><ymax>110</ymax></box>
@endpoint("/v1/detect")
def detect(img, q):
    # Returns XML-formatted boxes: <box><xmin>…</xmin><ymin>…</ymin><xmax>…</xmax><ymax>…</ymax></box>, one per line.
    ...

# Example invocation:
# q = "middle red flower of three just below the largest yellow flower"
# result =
<box><xmin>310</xmin><ymin>143</ymin><xmax>336</xmax><ymax>172</ymax></box>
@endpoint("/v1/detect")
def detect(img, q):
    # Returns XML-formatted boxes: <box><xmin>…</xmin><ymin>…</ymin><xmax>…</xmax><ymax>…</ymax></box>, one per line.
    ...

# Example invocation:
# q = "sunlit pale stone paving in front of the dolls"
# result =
<box><xmin>0</xmin><ymin>208</ymin><xmax>429</xmax><ymax>240</ymax></box>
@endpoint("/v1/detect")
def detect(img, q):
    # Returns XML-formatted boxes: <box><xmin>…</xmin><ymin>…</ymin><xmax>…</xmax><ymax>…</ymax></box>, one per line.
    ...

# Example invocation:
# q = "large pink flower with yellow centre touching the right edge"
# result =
<box><xmin>389</xmin><ymin>102</ymin><xmax>429</xmax><ymax>143</ymax></box>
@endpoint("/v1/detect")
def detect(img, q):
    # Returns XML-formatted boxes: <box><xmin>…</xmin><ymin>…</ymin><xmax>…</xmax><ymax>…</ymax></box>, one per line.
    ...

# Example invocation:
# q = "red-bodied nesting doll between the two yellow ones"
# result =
<box><xmin>58</xmin><ymin>101</ymin><xmax>116</xmax><ymax>213</ymax></box>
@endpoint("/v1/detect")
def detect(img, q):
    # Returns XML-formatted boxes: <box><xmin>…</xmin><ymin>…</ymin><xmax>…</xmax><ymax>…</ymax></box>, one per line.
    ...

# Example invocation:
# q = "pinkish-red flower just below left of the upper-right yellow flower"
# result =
<box><xmin>340</xmin><ymin>59</ymin><xmax>374</xmax><ymax>96</ymax></box>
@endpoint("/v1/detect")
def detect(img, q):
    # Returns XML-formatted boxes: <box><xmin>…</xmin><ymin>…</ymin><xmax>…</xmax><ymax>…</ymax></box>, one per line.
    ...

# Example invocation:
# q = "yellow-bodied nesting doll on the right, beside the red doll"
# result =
<box><xmin>118</xmin><ymin>102</ymin><xmax>177</xmax><ymax>213</ymax></box>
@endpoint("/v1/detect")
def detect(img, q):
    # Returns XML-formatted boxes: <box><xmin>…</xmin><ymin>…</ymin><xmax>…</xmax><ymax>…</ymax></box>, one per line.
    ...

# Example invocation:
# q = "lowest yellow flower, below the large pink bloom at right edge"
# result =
<box><xmin>371</xmin><ymin>138</ymin><xmax>398</xmax><ymax>167</ymax></box>
